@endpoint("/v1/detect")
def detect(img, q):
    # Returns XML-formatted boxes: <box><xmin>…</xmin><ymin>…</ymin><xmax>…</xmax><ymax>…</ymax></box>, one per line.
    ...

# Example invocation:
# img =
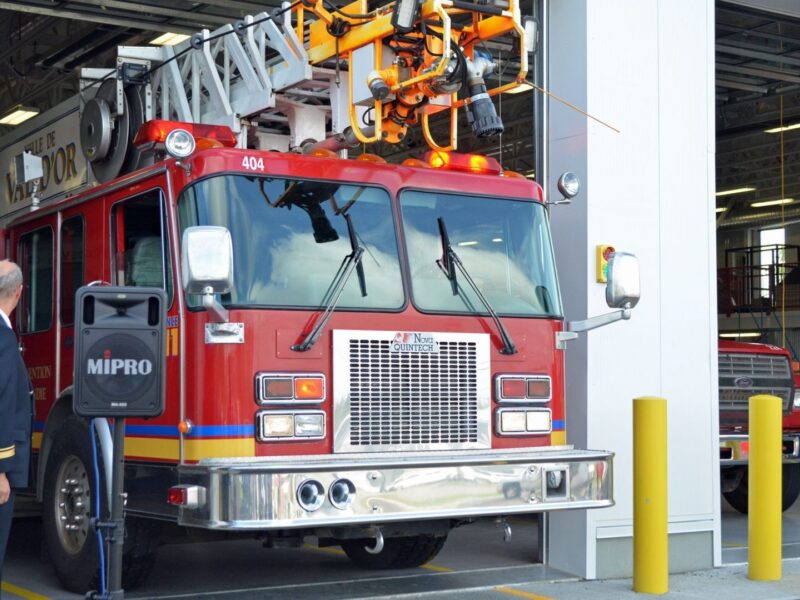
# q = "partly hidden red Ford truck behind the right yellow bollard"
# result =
<box><xmin>719</xmin><ymin>339</ymin><xmax>800</xmax><ymax>513</ymax></box>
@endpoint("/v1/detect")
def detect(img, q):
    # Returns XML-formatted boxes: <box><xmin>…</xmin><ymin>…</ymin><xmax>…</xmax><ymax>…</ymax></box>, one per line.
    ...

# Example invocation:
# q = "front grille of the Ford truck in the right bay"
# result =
<box><xmin>719</xmin><ymin>353</ymin><xmax>793</xmax><ymax>426</ymax></box>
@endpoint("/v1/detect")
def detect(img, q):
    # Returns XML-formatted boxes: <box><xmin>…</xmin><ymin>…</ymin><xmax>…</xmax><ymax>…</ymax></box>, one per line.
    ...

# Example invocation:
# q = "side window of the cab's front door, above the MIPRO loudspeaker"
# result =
<box><xmin>111</xmin><ymin>190</ymin><xmax>172</xmax><ymax>304</ymax></box>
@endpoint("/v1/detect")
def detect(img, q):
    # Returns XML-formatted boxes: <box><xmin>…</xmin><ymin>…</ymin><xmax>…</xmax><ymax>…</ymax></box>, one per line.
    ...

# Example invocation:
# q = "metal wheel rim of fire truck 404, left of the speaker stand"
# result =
<box><xmin>54</xmin><ymin>455</ymin><xmax>92</xmax><ymax>554</ymax></box>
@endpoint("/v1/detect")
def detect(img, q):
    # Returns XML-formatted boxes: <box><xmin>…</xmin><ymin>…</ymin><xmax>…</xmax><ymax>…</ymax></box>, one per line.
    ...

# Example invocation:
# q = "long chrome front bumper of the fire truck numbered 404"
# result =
<box><xmin>178</xmin><ymin>446</ymin><xmax>614</xmax><ymax>530</ymax></box>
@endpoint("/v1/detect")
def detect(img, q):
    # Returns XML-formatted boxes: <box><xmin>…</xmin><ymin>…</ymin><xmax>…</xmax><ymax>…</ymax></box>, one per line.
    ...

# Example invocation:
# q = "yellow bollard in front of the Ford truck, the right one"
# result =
<box><xmin>747</xmin><ymin>394</ymin><xmax>783</xmax><ymax>581</ymax></box>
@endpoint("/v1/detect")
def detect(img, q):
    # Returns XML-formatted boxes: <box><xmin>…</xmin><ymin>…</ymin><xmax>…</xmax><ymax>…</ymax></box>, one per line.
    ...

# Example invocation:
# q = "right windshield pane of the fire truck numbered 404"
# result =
<box><xmin>400</xmin><ymin>190</ymin><xmax>562</xmax><ymax>316</ymax></box>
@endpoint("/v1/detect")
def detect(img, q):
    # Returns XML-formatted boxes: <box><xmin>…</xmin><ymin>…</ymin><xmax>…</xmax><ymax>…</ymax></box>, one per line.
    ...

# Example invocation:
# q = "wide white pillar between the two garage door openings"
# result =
<box><xmin>547</xmin><ymin>0</ymin><xmax>720</xmax><ymax>579</ymax></box>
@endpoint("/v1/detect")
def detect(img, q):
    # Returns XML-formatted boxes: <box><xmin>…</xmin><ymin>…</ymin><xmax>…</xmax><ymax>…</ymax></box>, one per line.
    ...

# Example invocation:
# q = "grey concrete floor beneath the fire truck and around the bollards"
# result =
<box><xmin>2</xmin><ymin>501</ymin><xmax>800</xmax><ymax>600</ymax></box>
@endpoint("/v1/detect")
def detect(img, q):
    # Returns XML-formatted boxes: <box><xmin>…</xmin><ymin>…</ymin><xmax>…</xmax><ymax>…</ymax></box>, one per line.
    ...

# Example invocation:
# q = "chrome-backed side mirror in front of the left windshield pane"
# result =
<box><xmin>181</xmin><ymin>227</ymin><xmax>233</xmax><ymax>296</ymax></box>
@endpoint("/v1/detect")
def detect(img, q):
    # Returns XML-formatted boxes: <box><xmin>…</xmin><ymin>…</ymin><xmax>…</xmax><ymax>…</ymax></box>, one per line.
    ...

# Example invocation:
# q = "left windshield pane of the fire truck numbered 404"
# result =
<box><xmin>178</xmin><ymin>175</ymin><xmax>404</xmax><ymax>309</ymax></box>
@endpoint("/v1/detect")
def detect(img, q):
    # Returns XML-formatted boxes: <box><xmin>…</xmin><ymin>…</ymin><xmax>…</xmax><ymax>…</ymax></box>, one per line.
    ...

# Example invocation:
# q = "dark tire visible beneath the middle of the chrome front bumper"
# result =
<box><xmin>342</xmin><ymin>535</ymin><xmax>447</xmax><ymax>569</ymax></box>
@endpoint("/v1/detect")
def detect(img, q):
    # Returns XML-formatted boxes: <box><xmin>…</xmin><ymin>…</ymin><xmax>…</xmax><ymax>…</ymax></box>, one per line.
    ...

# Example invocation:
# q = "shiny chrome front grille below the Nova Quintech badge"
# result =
<box><xmin>334</xmin><ymin>330</ymin><xmax>490</xmax><ymax>452</ymax></box>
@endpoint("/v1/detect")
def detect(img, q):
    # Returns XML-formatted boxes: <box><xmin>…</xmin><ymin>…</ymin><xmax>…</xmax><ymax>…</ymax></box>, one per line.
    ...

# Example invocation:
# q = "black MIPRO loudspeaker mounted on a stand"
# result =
<box><xmin>72</xmin><ymin>286</ymin><xmax>167</xmax><ymax>418</ymax></box>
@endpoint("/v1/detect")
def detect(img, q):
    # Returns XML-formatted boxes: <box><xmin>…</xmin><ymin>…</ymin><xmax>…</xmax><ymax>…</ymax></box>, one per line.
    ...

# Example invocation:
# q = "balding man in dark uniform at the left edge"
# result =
<box><xmin>0</xmin><ymin>260</ymin><xmax>33</xmax><ymax>580</ymax></box>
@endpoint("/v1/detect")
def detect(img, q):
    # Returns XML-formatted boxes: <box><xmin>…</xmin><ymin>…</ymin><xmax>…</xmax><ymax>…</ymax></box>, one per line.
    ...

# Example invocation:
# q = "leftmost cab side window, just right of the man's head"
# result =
<box><xmin>17</xmin><ymin>227</ymin><xmax>53</xmax><ymax>333</ymax></box>
